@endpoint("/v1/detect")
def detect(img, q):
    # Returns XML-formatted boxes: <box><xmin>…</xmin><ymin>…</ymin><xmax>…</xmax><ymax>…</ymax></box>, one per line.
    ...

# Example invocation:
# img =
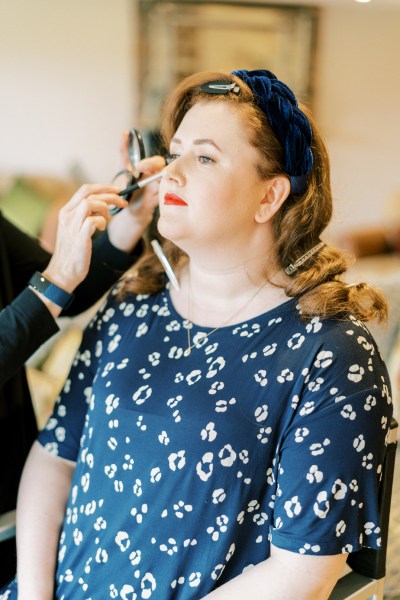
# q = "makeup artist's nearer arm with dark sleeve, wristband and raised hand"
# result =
<box><xmin>0</xmin><ymin>185</ymin><xmax>126</xmax><ymax>385</ymax></box>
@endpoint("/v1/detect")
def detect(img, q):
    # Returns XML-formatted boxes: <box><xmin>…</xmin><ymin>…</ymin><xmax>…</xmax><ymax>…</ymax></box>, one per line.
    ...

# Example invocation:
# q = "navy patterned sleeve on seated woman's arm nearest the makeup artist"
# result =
<box><xmin>38</xmin><ymin>293</ymin><xmax>114</xmax><ymax>462</ymax></box>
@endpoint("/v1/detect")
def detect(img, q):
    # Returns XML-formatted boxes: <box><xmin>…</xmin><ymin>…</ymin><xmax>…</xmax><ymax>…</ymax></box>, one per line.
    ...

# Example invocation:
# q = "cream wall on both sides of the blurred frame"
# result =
<box><xmin>0</xmin><ymin>0</ymin><xmax>400</xmax><ymax>236</ymax></box>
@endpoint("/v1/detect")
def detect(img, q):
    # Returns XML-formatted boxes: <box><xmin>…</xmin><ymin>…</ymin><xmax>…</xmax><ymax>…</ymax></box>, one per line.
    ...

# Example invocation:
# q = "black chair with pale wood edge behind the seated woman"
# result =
<box><xmin>329</xmin><ymin>419</ymin><xmax>398</xmax><ymax>600</ymax></box>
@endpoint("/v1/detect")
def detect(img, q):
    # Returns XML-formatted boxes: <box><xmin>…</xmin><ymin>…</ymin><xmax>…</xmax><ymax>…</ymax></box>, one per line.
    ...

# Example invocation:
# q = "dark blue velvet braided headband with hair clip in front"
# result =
<box><xmin>201</xmin><ymin>69</ymin><xmax>313</xmax><ymax>194</ymax></box>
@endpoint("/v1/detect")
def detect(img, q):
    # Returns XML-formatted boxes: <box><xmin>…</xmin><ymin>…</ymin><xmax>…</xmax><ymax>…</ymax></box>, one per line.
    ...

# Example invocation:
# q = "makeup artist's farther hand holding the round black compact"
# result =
<box><xmin>107</xmin><ymin>155</ymin><xmax>165</xmax><ymax>252</ymax></box>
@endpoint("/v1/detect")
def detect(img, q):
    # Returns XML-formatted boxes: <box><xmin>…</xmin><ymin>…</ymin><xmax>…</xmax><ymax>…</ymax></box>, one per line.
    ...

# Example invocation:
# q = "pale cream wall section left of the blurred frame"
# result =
<box><xmin>0</xmin><ymin>0</ymin><xmax>135</xmax><ymax>181</ymax></box>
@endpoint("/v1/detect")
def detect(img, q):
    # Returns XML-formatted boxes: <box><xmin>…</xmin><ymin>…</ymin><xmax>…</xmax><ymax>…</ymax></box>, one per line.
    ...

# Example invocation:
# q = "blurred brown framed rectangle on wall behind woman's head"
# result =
<box><xmin>138</xmin><ymin>0</ymin><xmax>318</xmax><ymax>130</ymax></box>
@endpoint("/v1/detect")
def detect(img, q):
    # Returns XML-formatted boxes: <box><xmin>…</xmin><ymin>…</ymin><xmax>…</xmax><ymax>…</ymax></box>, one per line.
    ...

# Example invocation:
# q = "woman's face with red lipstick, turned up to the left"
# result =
<box><xmin>158</xmin><ymin>102</ymin><xmax>265</xmax><ymax>253</ymax></box>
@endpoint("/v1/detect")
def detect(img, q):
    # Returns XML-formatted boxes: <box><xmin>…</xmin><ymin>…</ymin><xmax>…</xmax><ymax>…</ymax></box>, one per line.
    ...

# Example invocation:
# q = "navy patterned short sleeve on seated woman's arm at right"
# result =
<box><xmin>271</xmin><ymin>326</ymin><xmax>392</xmax><ymax>555</ymax></box>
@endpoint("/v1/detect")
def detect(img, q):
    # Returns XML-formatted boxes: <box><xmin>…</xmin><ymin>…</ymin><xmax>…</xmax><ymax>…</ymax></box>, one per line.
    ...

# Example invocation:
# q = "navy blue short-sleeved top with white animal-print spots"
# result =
<box><xmin>39</xmin><ymin>289</ymin><xmax>392</xmax><ymax>600</ymax></box>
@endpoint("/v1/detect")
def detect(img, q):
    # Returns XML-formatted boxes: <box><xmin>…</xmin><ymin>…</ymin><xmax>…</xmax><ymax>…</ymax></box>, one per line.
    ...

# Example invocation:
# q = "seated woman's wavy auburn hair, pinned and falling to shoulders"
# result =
<box><xmin>119</xmin><ymin>71</ymin><xmax>387</xmax><ymax>321</ymax></box>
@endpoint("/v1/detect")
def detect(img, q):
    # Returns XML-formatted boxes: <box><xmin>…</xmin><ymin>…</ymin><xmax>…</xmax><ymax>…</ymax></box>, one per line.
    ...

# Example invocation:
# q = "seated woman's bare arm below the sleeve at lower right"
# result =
<box><xmin>205</xmin><ymin>546</ymin><xmax>347</xmax><ymax>600</ymax></box>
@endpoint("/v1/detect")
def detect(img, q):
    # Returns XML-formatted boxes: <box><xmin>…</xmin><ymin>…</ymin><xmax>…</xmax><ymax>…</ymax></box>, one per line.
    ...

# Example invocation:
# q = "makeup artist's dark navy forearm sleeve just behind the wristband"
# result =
<box><xmin>0</xmin><ymin>288</ymin><xmax>58</xmax><ymax>386</ymax></box>
